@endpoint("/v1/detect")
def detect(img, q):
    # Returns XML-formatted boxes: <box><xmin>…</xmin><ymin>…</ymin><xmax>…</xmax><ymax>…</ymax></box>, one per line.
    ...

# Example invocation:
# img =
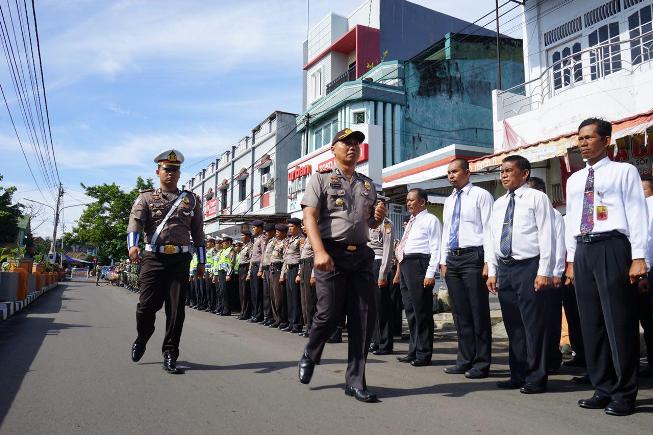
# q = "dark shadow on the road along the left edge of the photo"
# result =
<box><xmin>0</xmin><ymin>283</ymin><xmax>87</xmax><ymax>427</ymax></box>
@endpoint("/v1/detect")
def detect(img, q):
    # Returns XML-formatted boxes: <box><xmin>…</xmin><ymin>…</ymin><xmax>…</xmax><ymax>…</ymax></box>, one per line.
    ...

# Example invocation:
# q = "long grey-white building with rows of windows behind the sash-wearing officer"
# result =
<box><xmin>184</xmin><ymin>111</ymin><xmax>300</xmax><ymax>235</ymax></box>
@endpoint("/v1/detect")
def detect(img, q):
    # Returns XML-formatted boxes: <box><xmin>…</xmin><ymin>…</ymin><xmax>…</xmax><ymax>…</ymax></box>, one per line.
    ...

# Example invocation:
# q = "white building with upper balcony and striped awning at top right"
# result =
<box><xmin>472</xmin><ymin>0</ymin><xmax>653</xmax><ymax>207</ymax></box>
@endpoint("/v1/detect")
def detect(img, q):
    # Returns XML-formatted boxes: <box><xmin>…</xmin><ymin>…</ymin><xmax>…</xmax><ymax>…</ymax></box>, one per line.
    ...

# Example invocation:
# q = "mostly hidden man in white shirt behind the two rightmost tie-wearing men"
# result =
<box><xmin>528</xmin><ymin>177</ymin><xmax>567</xmax><ymax>372</ymax></box>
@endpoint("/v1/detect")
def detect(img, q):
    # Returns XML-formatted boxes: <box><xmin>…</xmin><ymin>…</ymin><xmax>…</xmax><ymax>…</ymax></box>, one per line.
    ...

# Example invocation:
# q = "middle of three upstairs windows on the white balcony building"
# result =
<box><xmin>588</xmin><ymin>22</ymin><xmax>621</xmax><ymax>80</ymax></box>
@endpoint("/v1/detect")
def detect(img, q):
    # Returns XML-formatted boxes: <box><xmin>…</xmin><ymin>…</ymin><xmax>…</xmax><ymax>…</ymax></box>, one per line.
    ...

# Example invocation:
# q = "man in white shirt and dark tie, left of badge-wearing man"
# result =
<box><xmin>487</xmin><ymin>155</ymin><xmax>555</xmax><ymax>394</ymax></box>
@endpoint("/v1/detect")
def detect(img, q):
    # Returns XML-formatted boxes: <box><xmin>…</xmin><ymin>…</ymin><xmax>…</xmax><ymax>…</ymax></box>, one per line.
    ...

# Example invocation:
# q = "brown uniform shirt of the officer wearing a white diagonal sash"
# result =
<box><xmin>127</xmin><ymin>189</ymin><xmax>205</xmax><ymax>247</ymax></box>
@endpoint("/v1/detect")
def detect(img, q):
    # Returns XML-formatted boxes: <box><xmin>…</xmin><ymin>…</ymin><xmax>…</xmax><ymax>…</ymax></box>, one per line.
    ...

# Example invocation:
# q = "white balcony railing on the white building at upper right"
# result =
<box><xmin>496</xmin><ymin>31</ymin><xmax>653</xmax><ymax>119</ymax></box>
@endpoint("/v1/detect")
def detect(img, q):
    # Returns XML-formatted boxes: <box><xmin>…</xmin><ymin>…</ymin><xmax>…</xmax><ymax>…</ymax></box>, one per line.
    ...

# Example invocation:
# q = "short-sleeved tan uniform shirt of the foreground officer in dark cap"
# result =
<box><xmin>301</xmin><ymin>167</ymin><xmax>376</xmax><ymax>245</ymax></box>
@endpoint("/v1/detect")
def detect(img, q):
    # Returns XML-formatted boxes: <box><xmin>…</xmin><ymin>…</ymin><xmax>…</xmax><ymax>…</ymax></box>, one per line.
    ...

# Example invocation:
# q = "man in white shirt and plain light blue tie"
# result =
<box><xmin>440</xmin><ymin>159</ymin><xmax>494</xmax><ymax>379</ymax></box>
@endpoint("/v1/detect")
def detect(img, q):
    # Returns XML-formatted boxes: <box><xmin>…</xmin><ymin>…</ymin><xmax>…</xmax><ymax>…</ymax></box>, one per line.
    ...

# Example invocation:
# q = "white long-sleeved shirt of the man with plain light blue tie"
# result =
<box><xmin>440</xmin><ymin>183</ymin><xmax>494</xmax><ymax>264</ymax></box>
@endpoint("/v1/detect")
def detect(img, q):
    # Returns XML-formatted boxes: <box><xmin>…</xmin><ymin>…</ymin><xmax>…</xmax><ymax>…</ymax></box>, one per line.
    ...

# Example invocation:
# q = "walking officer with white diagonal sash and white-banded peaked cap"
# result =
<box><xmin>127</xmin><ymin>149</ymin><xmax>206</xmax><ymax>373</ymax></box>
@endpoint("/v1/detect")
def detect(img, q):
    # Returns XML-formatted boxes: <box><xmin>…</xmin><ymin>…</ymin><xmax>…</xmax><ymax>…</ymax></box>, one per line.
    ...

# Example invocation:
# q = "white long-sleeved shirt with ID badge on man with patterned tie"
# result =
<box><xmin>565</xmin><ymin>157</ymin><xmax>648</xmax><ymax>262</ymax></box>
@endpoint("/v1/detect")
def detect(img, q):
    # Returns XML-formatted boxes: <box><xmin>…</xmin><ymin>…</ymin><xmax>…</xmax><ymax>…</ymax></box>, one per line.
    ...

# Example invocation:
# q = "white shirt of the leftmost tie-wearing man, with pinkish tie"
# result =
<box><xmin>404</xmin><ymin>210</ymin><xmax>442</xmax><ymax>278</ymax></box>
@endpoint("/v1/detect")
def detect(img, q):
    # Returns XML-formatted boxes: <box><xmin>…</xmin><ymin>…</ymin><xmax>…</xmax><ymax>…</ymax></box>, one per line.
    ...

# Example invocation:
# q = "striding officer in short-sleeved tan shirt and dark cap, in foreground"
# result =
<box><xmin>299</xmin><ymin>128</ymin><xmax>385</xmax><ymax>402</ymax></box>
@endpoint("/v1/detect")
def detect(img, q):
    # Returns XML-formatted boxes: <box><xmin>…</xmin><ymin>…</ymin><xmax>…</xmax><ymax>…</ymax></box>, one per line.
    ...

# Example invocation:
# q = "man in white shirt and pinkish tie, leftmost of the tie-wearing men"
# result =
<box><xmin>396</xmin><ymin>189</ymin><xmax>442</xmax><ymax>367</ymax></box>
